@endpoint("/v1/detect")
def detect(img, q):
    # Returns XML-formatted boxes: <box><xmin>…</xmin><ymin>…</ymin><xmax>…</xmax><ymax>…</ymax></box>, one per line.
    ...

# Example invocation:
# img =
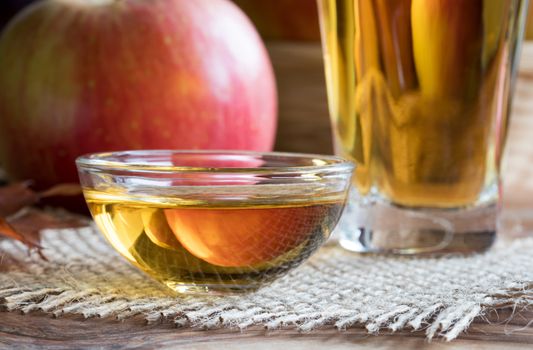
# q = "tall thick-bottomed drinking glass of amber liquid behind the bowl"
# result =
<box><xmin>318</xmin><ymin>0</ymin><xmax>527</xmax><ymax>253</ymax></box>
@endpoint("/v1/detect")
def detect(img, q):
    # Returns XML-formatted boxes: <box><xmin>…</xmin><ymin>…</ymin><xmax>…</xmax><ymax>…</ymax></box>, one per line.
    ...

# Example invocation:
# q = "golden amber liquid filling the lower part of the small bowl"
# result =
<box><xmin>85</xmin><ymin>190</ymin><xmax>344</xmax><ymax>292</ymax></box>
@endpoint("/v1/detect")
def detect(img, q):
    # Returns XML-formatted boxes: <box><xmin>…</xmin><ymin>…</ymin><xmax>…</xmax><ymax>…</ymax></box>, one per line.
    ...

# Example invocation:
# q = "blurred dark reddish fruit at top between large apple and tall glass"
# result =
<box><xmin>233</xmin><ymin>0</ymin><xmax>320</xmax><ymax>41</ymax></box>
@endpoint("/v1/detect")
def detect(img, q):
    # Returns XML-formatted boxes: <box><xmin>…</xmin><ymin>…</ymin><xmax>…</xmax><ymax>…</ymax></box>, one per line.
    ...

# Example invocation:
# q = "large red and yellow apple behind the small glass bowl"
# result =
<box><xmin>0</xmin><ymin>0</ymin><xmax>277</xmax><ymax>188</ymax></box>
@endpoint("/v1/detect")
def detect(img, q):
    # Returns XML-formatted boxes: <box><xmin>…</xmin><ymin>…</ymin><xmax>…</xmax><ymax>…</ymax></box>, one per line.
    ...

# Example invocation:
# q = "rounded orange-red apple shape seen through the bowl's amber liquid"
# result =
<box><xmin>165</xmin><ymin>207</ymin><xmax>321</xmax><ymax>267</ymax></box>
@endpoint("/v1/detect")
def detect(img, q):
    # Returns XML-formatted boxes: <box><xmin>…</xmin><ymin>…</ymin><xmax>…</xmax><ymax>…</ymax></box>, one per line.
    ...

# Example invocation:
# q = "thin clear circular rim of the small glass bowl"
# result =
<box><xmin>76</xmin><ymin>149</ymin><xmax>355</xmax><ymax>174</ymax></box>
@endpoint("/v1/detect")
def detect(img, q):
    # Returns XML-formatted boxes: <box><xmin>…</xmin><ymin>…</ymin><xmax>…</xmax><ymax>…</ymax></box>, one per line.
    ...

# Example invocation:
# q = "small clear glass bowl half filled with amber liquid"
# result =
<box><xmin>76</xmin><ymin>150</ymin><xmax>353</xmax><ymax>293</ymax></box>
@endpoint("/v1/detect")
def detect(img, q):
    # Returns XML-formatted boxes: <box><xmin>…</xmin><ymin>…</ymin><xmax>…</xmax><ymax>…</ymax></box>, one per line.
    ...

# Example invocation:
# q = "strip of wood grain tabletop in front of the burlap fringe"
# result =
<box><xmin>0</xmin><ymin>310</ymin><xmax>533</xmax><ymax>350</ymax></box>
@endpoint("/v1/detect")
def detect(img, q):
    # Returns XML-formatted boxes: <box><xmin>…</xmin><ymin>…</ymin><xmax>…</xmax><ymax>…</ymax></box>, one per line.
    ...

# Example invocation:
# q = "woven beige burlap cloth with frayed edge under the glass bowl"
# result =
<box><xmin>0</xmin><ymin>227</ymin><xmax>533</xmax><ymax>340</ymax></box>
